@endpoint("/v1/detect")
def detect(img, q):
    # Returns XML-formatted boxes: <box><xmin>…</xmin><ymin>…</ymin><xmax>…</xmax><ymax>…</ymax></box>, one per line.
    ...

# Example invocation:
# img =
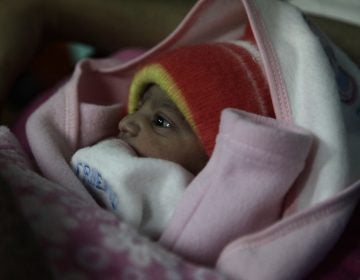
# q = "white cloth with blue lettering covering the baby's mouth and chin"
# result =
<box><xmin>71</xmin><ymin>138</ymin><xmax>194</xmax><ymax>238</ymax></box>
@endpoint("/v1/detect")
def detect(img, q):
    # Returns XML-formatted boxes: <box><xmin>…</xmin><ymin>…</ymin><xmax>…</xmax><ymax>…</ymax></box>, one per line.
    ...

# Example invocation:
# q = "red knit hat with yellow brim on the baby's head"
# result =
<box><xmin>128</xmin><ymin>41</ymin><xmax>274</xmax><ymax>156</ymax></box>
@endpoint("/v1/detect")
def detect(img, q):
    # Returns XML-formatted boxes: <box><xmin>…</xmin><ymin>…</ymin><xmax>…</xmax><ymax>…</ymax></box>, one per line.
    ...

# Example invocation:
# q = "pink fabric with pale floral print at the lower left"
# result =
<box><xmin>0</xmin><ymin>126</ymin><xmax>224</xmax><ymax>280</ymax></box>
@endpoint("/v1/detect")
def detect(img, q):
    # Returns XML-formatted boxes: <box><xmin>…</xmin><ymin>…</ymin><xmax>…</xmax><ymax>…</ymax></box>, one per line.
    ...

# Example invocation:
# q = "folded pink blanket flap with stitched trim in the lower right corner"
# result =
<box><xmin>217</xmin><ymin>179</ymin><xmax>360</xmax><ymax>279</ymax></box>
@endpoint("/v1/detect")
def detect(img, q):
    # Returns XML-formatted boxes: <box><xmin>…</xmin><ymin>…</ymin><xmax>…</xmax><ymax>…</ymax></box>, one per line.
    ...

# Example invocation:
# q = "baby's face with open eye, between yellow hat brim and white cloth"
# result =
<box><xmin>119</xmin><ymin>85</ymin><xmax>208</xmax><ymax>174</ymax></box>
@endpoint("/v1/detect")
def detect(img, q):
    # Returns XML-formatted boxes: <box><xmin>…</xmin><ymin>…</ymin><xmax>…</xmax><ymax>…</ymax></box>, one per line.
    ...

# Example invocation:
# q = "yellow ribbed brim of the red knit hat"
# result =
<box><xmin>128</xmin><ymin>64</ymin><xmax>196</xmax><ymax>131</ymax></box>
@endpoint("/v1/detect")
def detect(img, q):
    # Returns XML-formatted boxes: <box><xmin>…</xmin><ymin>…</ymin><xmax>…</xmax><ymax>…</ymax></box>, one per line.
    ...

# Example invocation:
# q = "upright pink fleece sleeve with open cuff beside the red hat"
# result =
<box><xmin>160</xmin><ymin>109</ymin><xmax>312</xmax><ymax>265</ymax></box>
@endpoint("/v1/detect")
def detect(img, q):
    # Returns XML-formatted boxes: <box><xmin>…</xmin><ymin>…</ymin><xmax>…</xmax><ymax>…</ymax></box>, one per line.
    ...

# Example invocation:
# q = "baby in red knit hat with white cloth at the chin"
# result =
<box><xmin>71</xmin><ymin>41</ymin><xmax>274</xmax><ymax>238</ymax></box>
